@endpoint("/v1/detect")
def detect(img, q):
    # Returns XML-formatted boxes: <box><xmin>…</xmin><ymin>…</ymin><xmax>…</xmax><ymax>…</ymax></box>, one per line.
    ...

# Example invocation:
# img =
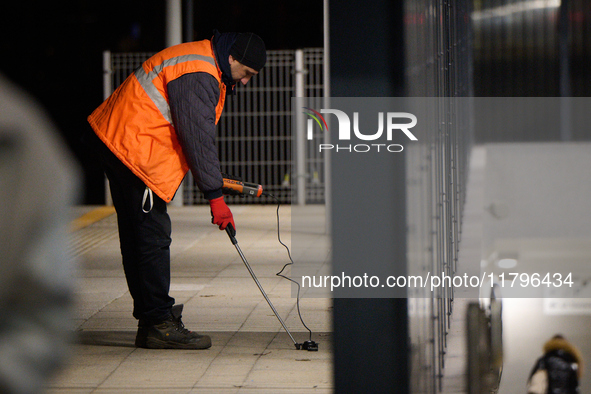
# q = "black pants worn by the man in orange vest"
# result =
<box><xmin>89</xmin><ymin>133</ymin><xmax>174</xmax><ymax>323</ymax></box>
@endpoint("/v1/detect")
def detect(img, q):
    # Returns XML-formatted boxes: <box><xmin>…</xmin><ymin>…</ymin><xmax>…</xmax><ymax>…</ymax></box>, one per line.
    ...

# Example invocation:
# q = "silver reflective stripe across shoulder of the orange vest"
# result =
<box><xmin>134</xmin><ymin>54</ymin><xmax>216</xmax><ymax>124</ymax></box>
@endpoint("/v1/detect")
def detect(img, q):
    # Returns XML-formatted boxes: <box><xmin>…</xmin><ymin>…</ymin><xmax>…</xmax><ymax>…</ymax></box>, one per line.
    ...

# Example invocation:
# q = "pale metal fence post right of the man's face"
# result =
<box><xmin>294</xmin><ymin>49</ymin><xmax>306</xmax><ymax>205</ymax></box>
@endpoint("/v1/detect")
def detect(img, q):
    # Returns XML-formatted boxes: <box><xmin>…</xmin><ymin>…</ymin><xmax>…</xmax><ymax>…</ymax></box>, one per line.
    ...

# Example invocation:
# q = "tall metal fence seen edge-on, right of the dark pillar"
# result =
<box><xmin>405</xmin><ymin>0</ymin><xmax>473</xmax><ymax>393</ymax></box>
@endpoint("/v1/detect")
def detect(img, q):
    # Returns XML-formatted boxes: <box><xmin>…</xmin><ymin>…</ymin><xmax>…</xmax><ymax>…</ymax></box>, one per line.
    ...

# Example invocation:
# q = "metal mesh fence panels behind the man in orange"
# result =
<box><xmin>104</xmin><ymin>48</ymin><xmax>324</xmax><ymax>205</ymax></box>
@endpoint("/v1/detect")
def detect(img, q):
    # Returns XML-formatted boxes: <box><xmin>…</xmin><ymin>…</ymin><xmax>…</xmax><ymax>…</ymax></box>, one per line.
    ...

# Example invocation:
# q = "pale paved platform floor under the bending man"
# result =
<box><xmin>48</xmin><ymin>205</ymin><xmax>333</xmax><ymax>394</ymax></box>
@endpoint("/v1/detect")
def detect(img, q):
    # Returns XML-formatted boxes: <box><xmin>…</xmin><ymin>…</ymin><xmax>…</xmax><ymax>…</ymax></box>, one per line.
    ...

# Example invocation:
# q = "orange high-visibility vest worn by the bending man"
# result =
<box><xmin>88</xmin><ymin>40</ymin><xmax>226</xmax><ymax>202</ymax></box>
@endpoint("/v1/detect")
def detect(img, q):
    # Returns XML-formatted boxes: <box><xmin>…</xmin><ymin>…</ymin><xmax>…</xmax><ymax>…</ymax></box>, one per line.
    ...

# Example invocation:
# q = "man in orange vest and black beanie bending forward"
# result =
<box><xmin>88</xmin><ymin>31</ymin><xmax>266</xmax><ymax>349</ymax></box>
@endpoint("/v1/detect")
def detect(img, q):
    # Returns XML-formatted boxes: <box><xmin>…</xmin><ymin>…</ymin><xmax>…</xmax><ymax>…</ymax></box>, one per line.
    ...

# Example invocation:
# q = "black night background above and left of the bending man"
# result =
<box><xmin>0</xmin><ymin>0</ymin><xmax>323</xmax><ymax>204</ymax></box>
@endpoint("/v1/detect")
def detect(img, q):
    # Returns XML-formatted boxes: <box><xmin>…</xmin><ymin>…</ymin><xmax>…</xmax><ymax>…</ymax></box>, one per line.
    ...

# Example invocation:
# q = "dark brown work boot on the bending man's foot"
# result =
<box><xmin>135</xmin><ymin>304</ymin><xmax>211</xmax><ymax>349</ymax></box>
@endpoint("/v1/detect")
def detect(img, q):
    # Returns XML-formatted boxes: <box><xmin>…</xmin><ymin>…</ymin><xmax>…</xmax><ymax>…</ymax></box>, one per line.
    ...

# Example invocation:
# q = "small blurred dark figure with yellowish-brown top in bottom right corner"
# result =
<box><xmin>527</xmin><ymin>335</ymin><xmax>583</xmax><ymax>394</ymax></box>
